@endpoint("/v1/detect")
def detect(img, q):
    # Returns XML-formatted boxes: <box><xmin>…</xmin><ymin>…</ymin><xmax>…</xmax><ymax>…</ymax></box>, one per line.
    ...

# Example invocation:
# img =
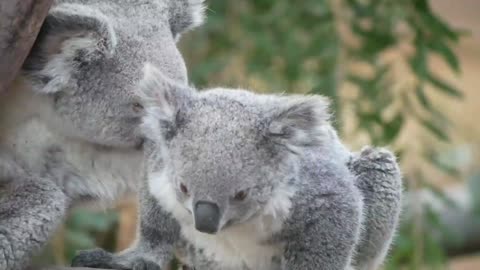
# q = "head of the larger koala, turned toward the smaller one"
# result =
<box><xmin>22</xmin><ymin>0</ymin><xmax>203</xmax><ymax>148</ymax></box>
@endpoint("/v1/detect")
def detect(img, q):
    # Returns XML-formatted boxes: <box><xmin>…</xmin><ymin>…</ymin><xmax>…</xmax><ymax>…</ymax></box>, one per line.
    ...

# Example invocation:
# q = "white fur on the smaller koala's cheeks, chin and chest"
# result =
<box><xmin>149</xmin><ymin>171</ymin><xmax>295</xmax><ymax>270</ymax></box>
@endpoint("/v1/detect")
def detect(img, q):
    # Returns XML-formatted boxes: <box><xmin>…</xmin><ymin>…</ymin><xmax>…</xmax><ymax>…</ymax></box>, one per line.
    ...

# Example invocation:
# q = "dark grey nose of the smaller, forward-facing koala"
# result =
<box><xmin>194</xmin><ymin>201</ymin><xmax>220</xmax><ymax>234</ymax></box>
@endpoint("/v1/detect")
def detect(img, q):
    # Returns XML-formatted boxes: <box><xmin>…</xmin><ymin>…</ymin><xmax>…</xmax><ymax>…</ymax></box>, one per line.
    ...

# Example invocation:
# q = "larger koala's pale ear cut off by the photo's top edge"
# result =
<box><xmin>169</xmin><ymin>0</ymin><xmax>206</xmax><ymax>39</ymax></box>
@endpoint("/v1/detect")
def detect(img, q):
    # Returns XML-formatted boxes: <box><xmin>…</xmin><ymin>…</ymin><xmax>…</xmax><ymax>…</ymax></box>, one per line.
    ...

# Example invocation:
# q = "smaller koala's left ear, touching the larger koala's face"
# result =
<box><xmin>138</xmin><ymin>63</ymin><xmax>192</xmax><ymax>141</ymax></box>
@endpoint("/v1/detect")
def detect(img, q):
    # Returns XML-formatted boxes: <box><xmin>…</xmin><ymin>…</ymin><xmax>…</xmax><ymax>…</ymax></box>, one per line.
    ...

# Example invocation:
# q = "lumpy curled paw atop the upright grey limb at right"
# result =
<box><xmin>348</xmin><ymin>146</ymin><xmax>399</xmax><ymax>174</ymax></box>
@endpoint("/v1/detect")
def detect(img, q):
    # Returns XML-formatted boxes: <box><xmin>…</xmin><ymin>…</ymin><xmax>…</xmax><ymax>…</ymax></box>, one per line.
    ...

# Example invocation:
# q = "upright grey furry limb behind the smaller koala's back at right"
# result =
<box><xmin>348</xmin><ymin>147</ymin><xmax>403</xmax><ymax>270</ymax></box>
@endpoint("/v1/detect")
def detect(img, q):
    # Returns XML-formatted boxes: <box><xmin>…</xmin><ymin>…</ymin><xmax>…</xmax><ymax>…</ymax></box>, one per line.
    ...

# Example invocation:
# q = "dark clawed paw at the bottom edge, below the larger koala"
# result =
<box><xmin>72</xmin><ymin>248</ymin><xmax>113</xmax><ymax>269</ymax></box>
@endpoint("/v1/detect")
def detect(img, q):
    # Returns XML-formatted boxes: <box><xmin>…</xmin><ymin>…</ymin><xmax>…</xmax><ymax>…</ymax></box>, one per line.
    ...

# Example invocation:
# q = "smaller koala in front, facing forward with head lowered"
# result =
<box><xmin>72</xmin><ymin>65</ymin><xmax>402</xmax><ymax>270</ymax></box>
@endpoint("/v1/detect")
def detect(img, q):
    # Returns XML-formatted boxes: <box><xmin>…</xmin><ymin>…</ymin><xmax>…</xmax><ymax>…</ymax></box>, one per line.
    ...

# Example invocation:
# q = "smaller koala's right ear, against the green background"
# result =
<box><xmin>267</xmin><ymin>96</ymin><xmax>330</xmax><ymax>152</ymax></box>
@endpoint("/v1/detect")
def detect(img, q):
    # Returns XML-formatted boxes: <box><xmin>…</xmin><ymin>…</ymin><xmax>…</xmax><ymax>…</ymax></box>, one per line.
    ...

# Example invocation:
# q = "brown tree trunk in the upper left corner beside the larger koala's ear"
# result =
<box><xmin>0</xmin><ymin>0</ymin><xmax>53</xmax><ymax>92</ymax></box>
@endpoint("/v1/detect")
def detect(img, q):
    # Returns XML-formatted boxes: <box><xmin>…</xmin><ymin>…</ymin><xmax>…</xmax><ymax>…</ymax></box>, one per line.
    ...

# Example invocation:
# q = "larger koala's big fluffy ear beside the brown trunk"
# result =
<box><xmin>23</xmin><ymin>4</ymin><xmax>117</xmax><ymax>93</ymax></box>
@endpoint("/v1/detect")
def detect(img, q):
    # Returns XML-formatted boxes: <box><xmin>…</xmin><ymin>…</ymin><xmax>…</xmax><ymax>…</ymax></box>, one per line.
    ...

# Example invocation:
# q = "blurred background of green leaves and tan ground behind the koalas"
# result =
<box><xmin>31</xmin><ymin>0</ymin><xmax>480</xmax><ymax>270</ymax></box>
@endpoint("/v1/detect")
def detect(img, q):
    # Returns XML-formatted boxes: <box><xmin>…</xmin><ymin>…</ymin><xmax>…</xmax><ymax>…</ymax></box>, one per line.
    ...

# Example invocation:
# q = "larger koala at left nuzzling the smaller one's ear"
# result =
<box><xmin>0</xmin><ymin>0</ymin><xmax>204</xmax><ymax>270</ymax></box>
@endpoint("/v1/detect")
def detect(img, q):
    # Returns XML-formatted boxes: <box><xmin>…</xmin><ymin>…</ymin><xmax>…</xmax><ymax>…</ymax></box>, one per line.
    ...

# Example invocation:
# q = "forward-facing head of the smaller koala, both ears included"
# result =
<box><xmin>141</xmin><ymin>66</ymin><xmax>329</xmax><ymax>233</ymax></box>
